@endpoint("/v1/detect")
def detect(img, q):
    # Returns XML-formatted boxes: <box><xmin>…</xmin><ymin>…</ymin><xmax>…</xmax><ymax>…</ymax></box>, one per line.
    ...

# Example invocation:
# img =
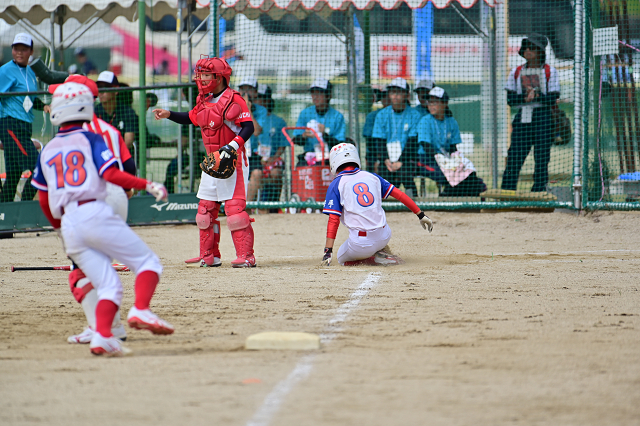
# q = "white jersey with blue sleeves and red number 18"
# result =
<box><xmin>31</xmin><ymin>127</ymin><xmax>117</xmax><ymax>219</ymax></box>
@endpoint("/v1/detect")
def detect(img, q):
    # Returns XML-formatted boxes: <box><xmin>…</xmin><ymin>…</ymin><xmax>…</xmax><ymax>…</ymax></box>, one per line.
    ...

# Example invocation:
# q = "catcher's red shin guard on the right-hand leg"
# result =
<box><xmin>225</xmin><ymin>199</ymin><xmax>256</xmax><ymax>268</ymax></box>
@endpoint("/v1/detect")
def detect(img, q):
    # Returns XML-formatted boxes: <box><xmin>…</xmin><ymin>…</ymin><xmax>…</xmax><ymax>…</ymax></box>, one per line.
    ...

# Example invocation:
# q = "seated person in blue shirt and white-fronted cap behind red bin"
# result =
<box><xmin>293</xmin><ymin>78</ymin><xmax>346</xmax><ymax>165</ymax></box>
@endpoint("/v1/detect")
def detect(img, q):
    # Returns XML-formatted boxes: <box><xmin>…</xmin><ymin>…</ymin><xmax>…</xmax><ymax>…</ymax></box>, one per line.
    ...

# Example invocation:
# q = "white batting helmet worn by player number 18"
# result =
<box><xmin>51</xmin><ymin>83</ymin><xmax>93</xmax><ymax>126</ymax></box>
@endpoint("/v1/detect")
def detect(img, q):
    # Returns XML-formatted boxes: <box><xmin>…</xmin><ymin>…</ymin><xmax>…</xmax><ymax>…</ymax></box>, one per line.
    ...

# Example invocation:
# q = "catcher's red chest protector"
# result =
<box><xmin>196</xmin><ymin>89</ymin><xmax>238</xmax><ymax>154</ymax></box>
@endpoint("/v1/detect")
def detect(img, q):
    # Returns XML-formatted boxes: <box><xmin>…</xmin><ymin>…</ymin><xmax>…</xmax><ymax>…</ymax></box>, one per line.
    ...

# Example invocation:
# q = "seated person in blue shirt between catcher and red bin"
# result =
<box><xmin>247</xmin><ymin>84</ymin><xmax>289</xmax><ymax>205</ymax></box>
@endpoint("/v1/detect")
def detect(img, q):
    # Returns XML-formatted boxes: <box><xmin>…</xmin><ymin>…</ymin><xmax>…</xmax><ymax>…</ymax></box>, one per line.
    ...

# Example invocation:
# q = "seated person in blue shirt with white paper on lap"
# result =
<box><xmin>418</xmin><ymin>86</ymin><xmax>487</xmax><ymax>197</ymax></box>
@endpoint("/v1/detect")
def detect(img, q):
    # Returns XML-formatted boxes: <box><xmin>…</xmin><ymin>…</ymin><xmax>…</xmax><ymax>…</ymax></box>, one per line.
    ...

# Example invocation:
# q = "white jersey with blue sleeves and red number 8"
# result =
<box><xmin>323</xmin><ymin>169</ymin><xmax>394</xmax><ymax>231</ymax></box>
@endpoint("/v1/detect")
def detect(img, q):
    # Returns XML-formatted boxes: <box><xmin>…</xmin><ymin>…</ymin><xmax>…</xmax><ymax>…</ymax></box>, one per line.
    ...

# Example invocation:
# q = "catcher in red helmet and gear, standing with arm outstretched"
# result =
<box><xmin>153</xmin><ymin>57</ymin><xmax>256</xmax><ymax>268</ymax></box>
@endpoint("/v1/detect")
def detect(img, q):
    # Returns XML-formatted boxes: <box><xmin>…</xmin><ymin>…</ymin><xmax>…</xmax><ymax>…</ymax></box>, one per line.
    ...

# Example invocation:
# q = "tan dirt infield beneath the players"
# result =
<box><xmin>0</xmin><ymin>212</ymin><xmax>640</xmax><ymax>426</ymax></box>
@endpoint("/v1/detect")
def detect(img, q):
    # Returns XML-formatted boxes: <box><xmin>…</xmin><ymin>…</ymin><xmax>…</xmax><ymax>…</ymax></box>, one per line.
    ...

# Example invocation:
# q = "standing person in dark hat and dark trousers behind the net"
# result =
<box><xmin>502</xmin><ymin>34</ymin><xmax>560</xmax><ymax>192</ymax></box>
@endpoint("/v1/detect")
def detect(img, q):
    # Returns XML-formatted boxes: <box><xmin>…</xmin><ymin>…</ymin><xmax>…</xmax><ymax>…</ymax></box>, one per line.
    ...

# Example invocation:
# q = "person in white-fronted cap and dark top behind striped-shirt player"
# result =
<box><xmin>95</xmin><ymin>71</ymin><xmax>138</xmax><ymax>150</ymax></box>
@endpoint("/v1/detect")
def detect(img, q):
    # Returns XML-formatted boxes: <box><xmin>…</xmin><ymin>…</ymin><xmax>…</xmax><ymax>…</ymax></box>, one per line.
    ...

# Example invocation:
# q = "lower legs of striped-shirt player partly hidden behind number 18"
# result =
<box><xmin>67</xmin><ymin>268</ymin><xmax>127</xmax><ymax>344</ymax></box>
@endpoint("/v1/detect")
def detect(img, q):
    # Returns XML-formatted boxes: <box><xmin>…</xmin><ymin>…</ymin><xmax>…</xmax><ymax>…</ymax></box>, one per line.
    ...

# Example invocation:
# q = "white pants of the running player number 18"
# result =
<box><xmin>61</xmin><ymin>200</ymin><xmax>162</xmax><ymax>306</ymax></box>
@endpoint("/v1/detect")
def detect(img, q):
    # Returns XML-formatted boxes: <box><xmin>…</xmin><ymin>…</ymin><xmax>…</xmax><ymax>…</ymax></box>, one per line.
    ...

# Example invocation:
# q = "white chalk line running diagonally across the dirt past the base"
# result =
<box><xmin>247</xmin><ymin>272</ymin><xmax>381</xmax><ymax>426</ymax></box>
